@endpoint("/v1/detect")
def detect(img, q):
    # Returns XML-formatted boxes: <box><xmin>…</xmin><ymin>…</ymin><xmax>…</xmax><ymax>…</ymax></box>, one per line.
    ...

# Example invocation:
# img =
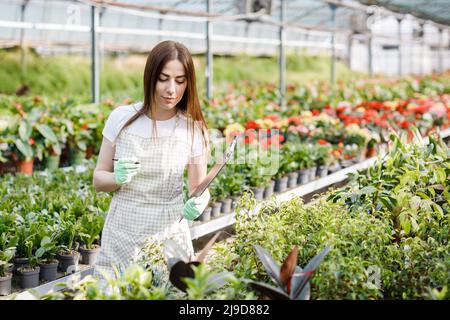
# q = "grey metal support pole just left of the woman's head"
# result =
<box><xmin>91</xmin><ymin>6</ymin><xmax>100</xmax><ymax>103</ymax></box>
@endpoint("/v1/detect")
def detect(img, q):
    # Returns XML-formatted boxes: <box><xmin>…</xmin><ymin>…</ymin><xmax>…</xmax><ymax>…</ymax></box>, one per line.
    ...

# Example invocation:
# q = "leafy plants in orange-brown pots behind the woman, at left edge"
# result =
<box><xmin>0</xmin><ymin>96</ymin><xmax>110</xmax><ymax>174</ymax></box>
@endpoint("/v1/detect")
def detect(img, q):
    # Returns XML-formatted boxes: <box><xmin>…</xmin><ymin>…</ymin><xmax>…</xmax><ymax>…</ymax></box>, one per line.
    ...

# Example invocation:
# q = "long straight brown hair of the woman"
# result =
<box><xmin>113</xmin><ymin>41</ymin><xmax>209</xmax><ymax>155</ymax></box>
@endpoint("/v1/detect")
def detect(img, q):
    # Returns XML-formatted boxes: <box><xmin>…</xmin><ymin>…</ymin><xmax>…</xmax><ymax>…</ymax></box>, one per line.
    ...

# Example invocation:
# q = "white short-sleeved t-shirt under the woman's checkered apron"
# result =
<box><xmin>102</xmin><ymin>102</ymin><xmax>206</xmax><ymax>157</ymax></box>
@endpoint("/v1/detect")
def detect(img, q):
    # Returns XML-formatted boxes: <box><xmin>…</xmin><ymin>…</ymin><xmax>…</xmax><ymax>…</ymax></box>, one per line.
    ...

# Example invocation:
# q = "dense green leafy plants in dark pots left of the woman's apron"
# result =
<box><xmin>0</xmin><ymin>164</ymin><xmax>106</xmax><ymax>295</ymax></box>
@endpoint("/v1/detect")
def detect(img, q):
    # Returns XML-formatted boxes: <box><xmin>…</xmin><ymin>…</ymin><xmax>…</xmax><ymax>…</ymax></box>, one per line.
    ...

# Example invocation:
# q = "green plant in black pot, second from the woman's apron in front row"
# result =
<box><xmin>56</xmin><ymin>219</ymin><xmax>80</xmax><ymax>272</ymax></box>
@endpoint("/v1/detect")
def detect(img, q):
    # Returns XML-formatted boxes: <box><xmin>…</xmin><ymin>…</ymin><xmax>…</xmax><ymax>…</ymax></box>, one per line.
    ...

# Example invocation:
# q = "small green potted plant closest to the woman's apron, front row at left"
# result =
<box><xmin>79</xmin><ymin>213</ymin><xmax>105</xmax><ymax>266</ymax></box>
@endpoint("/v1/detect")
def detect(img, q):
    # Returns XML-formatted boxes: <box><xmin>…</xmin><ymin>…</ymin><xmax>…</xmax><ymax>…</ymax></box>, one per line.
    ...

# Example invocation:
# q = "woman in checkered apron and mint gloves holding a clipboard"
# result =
<box><xmin>93</xmin><ymin>41</ymin><xmax>210</xmax><ymax>274</ymax></box>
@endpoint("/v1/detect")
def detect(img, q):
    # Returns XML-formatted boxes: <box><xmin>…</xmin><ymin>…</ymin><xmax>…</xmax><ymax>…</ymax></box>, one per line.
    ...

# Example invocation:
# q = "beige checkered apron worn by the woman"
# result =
<box><xmin>95</xmin><ymin>115</ymin><xmax>194</xmax><ymax>276</ymax></box>
